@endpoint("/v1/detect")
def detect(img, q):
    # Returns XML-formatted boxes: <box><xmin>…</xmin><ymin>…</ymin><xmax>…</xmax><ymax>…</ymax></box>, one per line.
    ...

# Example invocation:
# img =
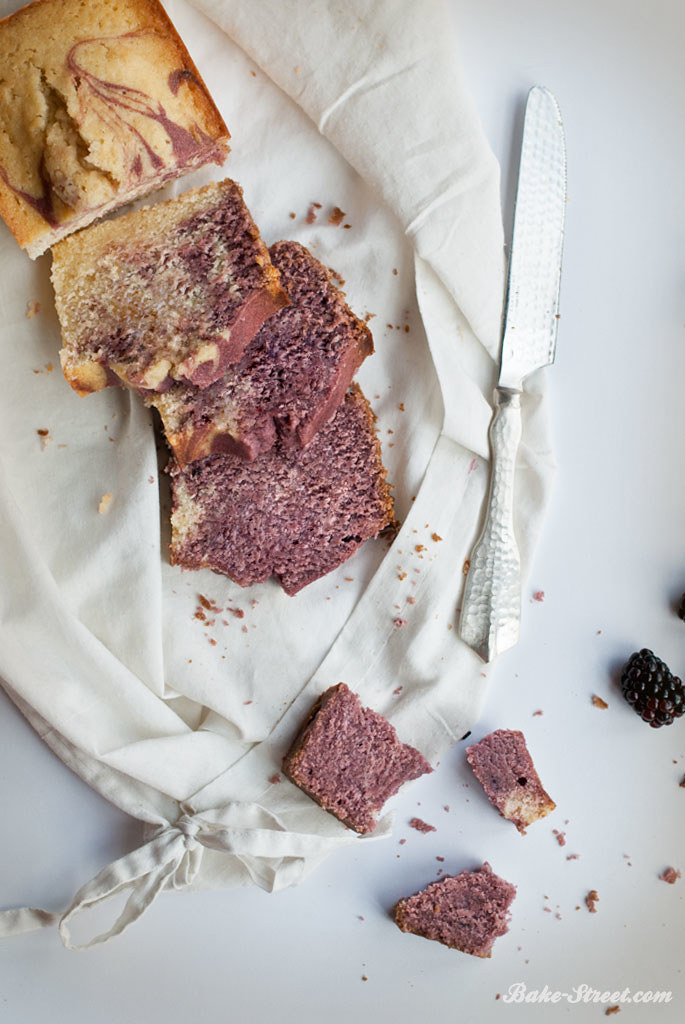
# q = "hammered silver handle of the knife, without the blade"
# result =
<box><xmin>460</xmin><ymin>388</ymin><xmax>521</xmax><ymax>662</ymax></box>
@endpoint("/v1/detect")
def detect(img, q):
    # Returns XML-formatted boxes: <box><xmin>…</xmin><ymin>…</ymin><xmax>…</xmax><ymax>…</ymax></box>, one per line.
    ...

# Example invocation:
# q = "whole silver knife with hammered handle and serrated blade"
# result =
<box><xmin>460</xmin><ymin>85</ymin><xmax>566</xmax><ymax>662</ymax></box>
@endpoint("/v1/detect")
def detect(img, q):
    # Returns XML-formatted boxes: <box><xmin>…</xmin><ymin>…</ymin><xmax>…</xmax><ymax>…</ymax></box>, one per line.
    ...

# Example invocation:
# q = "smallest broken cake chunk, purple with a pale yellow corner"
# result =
<box><xmin>466</xmin><ymin>729</ymin><xmax>556</xmax><ymax>833</ymax></box>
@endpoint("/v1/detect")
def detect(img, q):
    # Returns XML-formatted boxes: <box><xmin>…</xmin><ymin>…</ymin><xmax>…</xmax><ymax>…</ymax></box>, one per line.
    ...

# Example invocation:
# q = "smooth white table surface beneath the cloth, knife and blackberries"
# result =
<box><xmin>0</xmin><ymin>0</ymin><xmax>685</xmax><ymax>1024</ymax></box>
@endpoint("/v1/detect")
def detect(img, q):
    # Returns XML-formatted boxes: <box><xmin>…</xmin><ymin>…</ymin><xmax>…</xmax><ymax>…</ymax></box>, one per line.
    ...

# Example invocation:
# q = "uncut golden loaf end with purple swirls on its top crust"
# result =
<box><xmin>0</xmin><ymin>0</ymin><xmax>229</xmax><ymax>259</ymax></box>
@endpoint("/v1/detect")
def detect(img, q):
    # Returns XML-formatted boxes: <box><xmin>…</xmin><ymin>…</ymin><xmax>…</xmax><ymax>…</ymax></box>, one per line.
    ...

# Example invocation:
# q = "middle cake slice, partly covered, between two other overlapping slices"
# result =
<box><xmin>147</xmin><ymin>242</ymin><xmax>374</xmax><ymax>467</ymax></box>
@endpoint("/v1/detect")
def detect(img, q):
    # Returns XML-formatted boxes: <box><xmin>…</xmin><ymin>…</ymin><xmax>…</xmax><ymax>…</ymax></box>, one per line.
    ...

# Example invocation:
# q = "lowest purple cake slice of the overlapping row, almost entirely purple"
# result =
<box><xmin>169</xmin><ymin>385</ymin><xmax>394</xmax><ymax>594</ymax></box>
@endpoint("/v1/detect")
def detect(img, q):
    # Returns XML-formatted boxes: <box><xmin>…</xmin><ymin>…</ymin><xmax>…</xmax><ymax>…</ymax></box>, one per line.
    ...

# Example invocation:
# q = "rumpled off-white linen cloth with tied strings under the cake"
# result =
<box><xmin>0</xmin><ymin>0</ymin><xmax>553</xmax><ymax>948</ymax></box>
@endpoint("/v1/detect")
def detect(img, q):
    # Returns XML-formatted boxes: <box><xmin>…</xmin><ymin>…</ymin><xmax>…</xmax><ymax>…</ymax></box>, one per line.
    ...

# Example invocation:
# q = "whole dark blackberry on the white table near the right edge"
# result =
<box><xmin>620</xmin><ymin>647</ymin><xmax>685</xmax><ymax>729</ymax></box>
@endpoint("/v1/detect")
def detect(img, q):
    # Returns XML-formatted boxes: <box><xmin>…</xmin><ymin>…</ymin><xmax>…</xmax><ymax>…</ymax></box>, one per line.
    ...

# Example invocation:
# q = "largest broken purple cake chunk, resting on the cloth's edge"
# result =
<box><xmin>283</xmin><ymin>683</ymin><xmax>432</xmax><ymax>835</ymax></box>
